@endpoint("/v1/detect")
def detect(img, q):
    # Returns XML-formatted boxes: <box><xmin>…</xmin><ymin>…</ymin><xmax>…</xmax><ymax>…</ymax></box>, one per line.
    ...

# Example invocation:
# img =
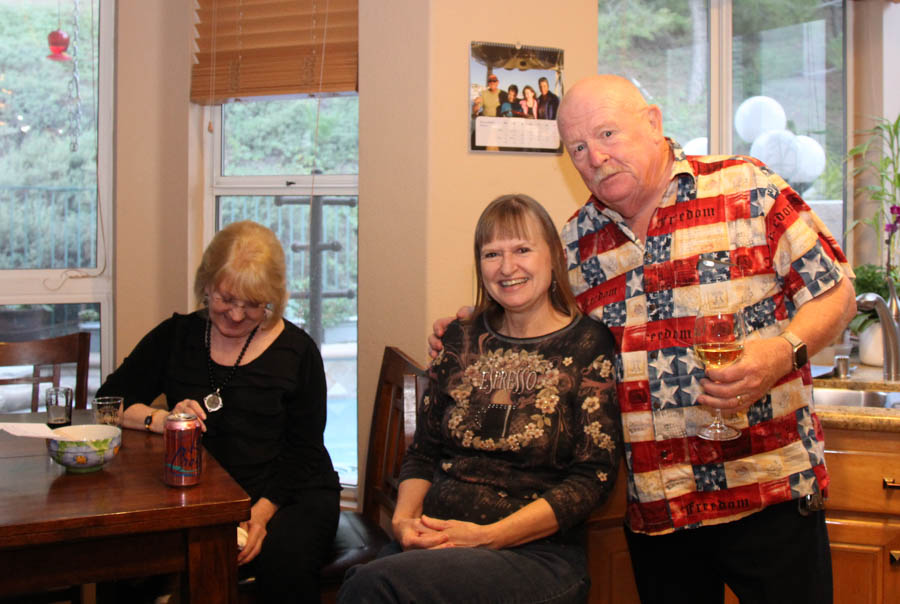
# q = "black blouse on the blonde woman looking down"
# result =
<box><xmin>97</xmin><ymin>311</ymin><xmax>340</xmax><ymax>505</ymax></box>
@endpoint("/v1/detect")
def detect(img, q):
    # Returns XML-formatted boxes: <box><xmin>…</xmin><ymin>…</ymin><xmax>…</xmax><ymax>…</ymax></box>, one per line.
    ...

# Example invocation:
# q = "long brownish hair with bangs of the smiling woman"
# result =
<box><xmin>473</xmin><ymin>193</ymin><xmax>579</xmax><ymax>325</ymax></box>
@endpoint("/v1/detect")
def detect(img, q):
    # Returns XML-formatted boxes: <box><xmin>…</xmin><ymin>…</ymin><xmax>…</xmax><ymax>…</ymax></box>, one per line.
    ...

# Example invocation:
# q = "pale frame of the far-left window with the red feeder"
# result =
<box><xmin>0</xmin><ymin>0</ymin><xmax>116</xmax><ymax>380</ymax></box>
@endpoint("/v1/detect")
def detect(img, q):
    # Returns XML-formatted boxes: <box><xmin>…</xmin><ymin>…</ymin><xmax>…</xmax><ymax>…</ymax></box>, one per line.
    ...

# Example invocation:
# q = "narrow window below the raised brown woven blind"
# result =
<box><xmin>209</xmin><ymin>94</ymin><xmax>358</xmax><ymax>485</ymax></box>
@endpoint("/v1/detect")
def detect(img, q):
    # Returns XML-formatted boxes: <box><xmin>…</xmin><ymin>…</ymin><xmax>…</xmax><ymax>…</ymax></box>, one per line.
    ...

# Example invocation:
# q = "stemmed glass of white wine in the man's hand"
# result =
<box><xmin>694</xmin><ymin>307</ymin><xmax>747</xmax><ymax>440</ymax></box>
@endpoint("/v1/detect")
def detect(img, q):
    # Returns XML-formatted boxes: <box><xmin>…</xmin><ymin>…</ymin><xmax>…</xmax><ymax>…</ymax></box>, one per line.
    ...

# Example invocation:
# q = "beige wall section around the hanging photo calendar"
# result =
<box><xmin>359</xmin><ymin>0</ymin><xmax>597</xmax><ymax>482</ymax></box>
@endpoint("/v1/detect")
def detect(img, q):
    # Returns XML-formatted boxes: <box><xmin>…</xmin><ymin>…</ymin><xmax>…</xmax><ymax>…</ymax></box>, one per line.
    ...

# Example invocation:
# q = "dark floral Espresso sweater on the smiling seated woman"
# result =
<box><xmin>400</xmin><ymin>316</ymin><xmax>621</xmax><ymax>534</ymax></box>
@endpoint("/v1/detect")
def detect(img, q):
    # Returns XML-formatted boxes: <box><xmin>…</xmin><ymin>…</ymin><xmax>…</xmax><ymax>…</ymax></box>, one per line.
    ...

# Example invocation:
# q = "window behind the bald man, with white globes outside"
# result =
<box><xmin>598</xmin><ymin>0</ymin><xmax>846</xmax><ymax>240</ymax></box>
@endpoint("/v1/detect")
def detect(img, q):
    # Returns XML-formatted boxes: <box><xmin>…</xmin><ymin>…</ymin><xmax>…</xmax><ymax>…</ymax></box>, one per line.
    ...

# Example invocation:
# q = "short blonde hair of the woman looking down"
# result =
<box><xmin>194</xmin><ymin>220</ymin><xmax>287</xmax><ymax>327</ymax></box>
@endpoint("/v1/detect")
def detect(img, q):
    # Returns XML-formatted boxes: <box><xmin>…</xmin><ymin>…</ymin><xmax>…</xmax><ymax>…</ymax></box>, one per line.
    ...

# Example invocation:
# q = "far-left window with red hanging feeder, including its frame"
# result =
<box><xmin>0</xmin><ymin>0</ymin><xmax>115</xmax><ymax>412</ymax></box>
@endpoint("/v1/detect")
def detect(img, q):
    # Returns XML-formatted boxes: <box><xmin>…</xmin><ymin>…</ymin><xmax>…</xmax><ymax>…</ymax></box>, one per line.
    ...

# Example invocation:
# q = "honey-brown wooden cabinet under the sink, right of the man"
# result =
<box><xmin>825</xmin><ymin>428</ymin><xmax>900</xmax><ymax>604</ymax></box>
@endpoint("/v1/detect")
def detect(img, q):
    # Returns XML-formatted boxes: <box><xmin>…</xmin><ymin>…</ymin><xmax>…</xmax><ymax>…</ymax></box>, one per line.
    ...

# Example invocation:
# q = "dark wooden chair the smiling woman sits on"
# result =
<box><xmin>240</xmin><ymin>346</ymin><xmax>428</xmax><ymax>603</ymax></box>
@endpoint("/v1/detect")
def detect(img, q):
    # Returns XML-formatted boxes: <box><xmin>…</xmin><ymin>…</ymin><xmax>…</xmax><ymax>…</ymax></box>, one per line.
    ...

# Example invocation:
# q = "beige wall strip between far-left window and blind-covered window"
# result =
<box><xmin>115</xmin><ymin>1</ymin><xmax>202</xmax><ymax>365</ymax></box>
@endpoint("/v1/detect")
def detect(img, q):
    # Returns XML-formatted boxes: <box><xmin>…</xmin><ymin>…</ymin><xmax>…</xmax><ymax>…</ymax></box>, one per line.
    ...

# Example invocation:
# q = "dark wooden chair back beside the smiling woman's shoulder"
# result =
<box><xmin>362</xmin><ymin>346</ymin><xmax>428</xmax><ymax>524</ymax></box>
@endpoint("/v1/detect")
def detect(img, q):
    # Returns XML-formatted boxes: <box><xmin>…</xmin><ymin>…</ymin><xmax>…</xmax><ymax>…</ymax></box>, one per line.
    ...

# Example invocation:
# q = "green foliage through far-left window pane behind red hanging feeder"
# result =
<box><xmin>0</xmin><ymin>0</ymin><xmax>99</xmax><ymax>269</ymax></box>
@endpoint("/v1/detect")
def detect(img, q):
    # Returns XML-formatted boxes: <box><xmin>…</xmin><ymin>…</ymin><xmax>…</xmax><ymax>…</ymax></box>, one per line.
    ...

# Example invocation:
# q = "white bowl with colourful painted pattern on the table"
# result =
<box><xmin>47</xmin><ymin>424</ymin><xmax>122</xmax><ymax>474</ymax></box>
